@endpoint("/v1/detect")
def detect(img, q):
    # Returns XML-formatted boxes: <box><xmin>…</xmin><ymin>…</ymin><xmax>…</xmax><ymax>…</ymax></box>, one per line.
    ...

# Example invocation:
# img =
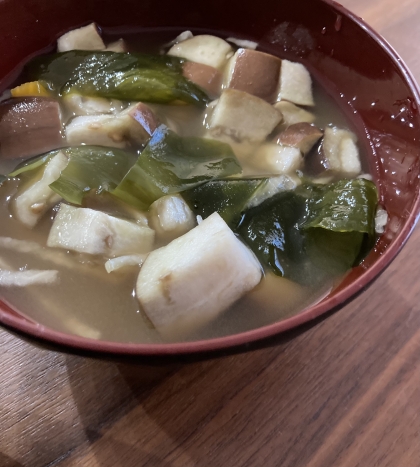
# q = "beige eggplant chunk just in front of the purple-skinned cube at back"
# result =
<box><xmin>209</xmin><ymin>89</ymin><xmax>282</xmax><ymax>142</ymax></box>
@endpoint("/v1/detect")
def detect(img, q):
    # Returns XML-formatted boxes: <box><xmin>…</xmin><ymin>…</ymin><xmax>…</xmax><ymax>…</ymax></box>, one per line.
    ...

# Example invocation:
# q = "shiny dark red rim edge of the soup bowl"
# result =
<box><xmin>0</xmin><ymin>0</ymin><xmax>420</xmax><ymax>356</ymax></box>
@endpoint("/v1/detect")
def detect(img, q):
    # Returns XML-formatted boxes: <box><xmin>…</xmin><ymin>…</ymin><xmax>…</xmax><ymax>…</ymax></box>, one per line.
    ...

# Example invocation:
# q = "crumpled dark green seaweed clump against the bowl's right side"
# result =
<box><xmin>238</xmin><ymin>179</ymin><xmax>378</xmax><ymax>284</ymax></box>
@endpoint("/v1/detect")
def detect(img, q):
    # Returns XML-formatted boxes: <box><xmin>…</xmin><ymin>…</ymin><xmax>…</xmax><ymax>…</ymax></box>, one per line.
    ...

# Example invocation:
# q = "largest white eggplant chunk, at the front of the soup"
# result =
<box><xmin>136</xmin><ymin>213</ymin><xmax>262</xmax><ymax>338</ymax></box>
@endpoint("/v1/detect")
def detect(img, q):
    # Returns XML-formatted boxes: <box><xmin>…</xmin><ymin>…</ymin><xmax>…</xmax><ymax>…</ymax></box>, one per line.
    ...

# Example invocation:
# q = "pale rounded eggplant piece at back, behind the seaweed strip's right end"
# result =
<box><xmin>168</xmin><ymin>34</ymin><xmax>233</xmax><ymax>70</ymax></box>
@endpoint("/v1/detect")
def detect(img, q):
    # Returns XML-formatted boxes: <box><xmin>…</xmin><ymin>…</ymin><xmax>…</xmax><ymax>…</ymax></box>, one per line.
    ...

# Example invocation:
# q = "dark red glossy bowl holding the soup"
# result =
<box><xmin>0</xmin><ymin>0</ymin><xmax>420</xmax><ymax>355</ymax></box>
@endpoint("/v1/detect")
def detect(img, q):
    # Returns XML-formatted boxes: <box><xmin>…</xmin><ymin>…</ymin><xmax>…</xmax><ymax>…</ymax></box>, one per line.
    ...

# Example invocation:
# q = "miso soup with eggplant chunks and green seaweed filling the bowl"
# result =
<box><xmin>0</xmin><ymin>24</ymin><xmax>386</xmax><ymax>343</ymax></box>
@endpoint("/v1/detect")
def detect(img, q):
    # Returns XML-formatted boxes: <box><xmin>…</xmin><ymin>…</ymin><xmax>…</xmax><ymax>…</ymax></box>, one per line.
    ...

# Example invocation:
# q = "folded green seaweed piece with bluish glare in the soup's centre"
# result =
<box><xmin>113</xmin><ymin>125</ymin><xmax>242</xmax><ymax>209</ymax></box>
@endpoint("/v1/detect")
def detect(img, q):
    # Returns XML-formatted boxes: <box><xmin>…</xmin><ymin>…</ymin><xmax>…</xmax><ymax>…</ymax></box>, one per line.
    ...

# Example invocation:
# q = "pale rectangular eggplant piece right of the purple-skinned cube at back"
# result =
<box><xmin>277</xmin><ymin>60</ymin><xmax>315</xmax><ymax>106</ymax></box>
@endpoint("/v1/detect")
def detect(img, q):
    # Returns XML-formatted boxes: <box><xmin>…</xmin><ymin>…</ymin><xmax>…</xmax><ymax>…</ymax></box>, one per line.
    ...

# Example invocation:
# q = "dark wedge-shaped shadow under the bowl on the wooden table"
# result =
<box><xmin>59</xmin><ymin>286</ymin><xmax>374</xmax><ymax>467</ymax></box>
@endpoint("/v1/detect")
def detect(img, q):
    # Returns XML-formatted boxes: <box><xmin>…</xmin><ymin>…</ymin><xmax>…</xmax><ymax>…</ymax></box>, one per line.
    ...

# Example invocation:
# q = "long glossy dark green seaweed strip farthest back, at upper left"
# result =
<box><xmin>27</xmin><ymin>51</ymin><xmax>209</xmax><ymax>105</ymax></box>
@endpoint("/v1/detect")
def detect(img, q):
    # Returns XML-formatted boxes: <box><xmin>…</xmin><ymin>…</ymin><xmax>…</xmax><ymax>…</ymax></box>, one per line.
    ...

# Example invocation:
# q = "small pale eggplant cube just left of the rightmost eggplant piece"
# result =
<box><xmin>251</xmin><ymin>143</ymin><xmax>303</xmax><ymax>175</ymax></box>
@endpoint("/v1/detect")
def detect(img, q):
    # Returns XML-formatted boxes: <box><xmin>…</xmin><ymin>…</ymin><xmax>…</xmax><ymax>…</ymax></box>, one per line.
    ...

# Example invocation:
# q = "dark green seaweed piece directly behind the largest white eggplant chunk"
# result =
<box><xmin>182</xmin><ymin>178</ymin><xmax>267</xmax><ymax>229</ymax></box>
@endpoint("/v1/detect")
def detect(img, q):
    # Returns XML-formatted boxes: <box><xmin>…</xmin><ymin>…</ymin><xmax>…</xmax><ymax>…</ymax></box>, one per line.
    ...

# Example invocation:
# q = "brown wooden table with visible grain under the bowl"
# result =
<box><xmin>0</xmin><ymin>0</ymin><xmax>420</xmax><ymax>467</ymax></box>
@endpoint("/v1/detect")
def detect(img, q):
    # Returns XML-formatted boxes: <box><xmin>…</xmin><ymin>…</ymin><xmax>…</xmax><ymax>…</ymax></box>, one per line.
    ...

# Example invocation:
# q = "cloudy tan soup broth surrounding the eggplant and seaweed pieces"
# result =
<box><xmin>0</xmin><ymin>28</ymin><xmax>378</xmax><ymax>343</ymax></box>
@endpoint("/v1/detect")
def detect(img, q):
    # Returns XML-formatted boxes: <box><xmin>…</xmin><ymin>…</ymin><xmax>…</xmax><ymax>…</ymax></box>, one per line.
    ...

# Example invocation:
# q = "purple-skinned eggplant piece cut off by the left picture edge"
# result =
<box><xmin>0</xmin><ymin>97</ymin><xmax>63</xmax><ymax>159</ymax></box>
